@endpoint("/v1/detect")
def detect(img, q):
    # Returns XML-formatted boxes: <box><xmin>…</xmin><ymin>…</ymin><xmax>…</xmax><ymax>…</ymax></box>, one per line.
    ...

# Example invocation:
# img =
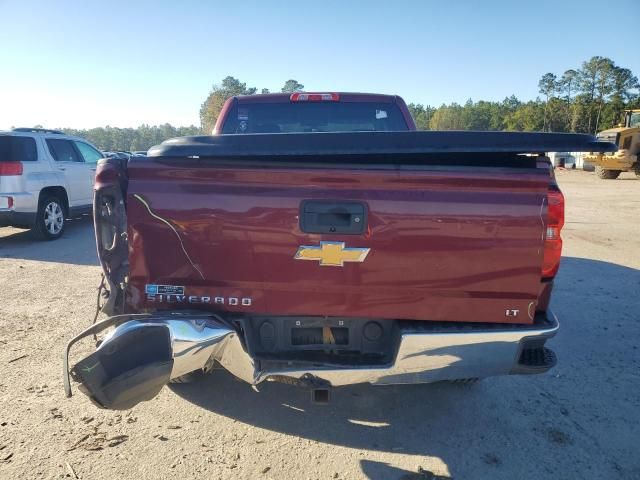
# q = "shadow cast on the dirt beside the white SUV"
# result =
<box><xmin>0</xmin><ymin>215</ymin><xmax>98</xmax><ymax>265</ymax></box>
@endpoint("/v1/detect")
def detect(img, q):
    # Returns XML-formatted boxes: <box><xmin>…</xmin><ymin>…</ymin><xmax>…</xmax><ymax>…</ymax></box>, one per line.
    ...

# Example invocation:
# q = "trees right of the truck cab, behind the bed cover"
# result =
<box><xmin>409</xmin><ymin>57</ymin><xmax>640</xmax><ymax>133</ymax></box>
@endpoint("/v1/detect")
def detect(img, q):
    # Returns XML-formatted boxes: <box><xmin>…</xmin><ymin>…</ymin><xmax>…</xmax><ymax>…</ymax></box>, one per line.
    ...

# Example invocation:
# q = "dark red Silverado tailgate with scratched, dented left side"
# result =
<box><xmin>127</xmin><ymin>158</ymin><xmax>549</xmax><ymax>323</ymax></box>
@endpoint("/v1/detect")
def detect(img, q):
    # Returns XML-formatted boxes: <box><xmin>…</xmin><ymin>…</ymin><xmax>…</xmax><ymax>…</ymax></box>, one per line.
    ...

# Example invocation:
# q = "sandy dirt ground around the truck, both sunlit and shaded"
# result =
<box><xmin>0</xmin><ymin>171</ymin><xmax>640</xmax><ymax>480</ymax></box>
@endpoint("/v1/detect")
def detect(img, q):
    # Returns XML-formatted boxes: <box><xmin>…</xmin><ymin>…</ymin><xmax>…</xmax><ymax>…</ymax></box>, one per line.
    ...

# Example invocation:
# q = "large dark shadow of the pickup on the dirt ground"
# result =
<box><xmin>171</xmin><ymin>258</ymin><xmax>640</xmax><ymax>479</ymax></box>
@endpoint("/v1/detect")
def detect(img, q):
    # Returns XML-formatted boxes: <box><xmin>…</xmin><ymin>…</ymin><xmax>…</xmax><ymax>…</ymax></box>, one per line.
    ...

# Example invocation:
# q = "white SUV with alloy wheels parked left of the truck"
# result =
<box><xmin>0</xmin><ymin>128</ymin><xmax>103</xmax><ymax>240</ymax></box>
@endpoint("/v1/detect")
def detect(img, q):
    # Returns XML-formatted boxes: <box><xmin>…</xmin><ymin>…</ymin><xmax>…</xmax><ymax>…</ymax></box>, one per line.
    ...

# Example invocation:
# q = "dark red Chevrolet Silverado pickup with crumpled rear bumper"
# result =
<box><xmin>64</xmin><ymin>93</ymin><xmax>615</xmax><ymax>409</ymax></box>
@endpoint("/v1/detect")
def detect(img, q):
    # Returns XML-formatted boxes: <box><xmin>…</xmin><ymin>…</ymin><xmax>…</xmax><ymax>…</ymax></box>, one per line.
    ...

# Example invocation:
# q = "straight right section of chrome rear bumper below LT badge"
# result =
<box><xmin>253</xmin><ymin>315</ymin><xmax>559</xmax><ymax>387</ymax></box>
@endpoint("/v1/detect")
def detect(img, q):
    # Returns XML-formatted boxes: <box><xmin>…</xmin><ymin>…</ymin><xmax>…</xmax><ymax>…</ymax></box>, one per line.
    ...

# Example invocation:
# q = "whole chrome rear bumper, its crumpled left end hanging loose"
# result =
<box><xmin>64</xmin><ymin>313</ymin><xmax>559</xmax><ymax>410</ymax></box>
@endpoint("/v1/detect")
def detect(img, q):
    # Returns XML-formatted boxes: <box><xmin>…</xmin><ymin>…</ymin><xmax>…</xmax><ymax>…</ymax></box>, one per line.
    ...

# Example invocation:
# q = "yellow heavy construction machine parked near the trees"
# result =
<box><xmin>584</xmin><ymin>109</ymin><xmax>640</xmax><ymax>180</ymax></box>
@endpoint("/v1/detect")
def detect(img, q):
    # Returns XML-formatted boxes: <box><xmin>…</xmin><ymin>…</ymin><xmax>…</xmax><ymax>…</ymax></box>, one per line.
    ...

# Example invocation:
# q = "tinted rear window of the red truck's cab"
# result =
<box><xmin>222</xmin><ymin>102</ymin><xmax>407</xmax><ymax>133</ymax></box>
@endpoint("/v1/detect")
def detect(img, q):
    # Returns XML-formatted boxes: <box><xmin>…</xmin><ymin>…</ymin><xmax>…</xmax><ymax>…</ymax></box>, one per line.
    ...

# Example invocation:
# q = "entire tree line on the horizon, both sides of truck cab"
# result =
<box><xmin>57</xmin><ymin>57</ymin><xmax>640</xmax><ymax>151</ymax></box>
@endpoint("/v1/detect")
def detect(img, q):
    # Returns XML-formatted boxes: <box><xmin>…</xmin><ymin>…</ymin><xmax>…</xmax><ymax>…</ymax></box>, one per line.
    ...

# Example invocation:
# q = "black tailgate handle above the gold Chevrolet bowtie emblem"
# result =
<box><xmin>300</xmin><ymin>200</ymin><xmax>367</xmax><ymax>235</ymax></box>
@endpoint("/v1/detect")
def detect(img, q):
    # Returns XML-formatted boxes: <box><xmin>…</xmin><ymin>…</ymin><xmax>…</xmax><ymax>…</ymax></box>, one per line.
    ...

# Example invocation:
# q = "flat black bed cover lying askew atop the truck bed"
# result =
<box><xmin>148</xmin><ymin>131</ymin><xmax>617</xmax><ymax>158</ymax></box>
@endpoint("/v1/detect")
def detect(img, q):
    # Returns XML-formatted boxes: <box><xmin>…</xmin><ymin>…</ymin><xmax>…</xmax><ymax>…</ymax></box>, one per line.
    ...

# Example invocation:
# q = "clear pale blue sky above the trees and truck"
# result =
<box><xmin>0</xmin><ymin>0</ymin><xmax>640</xmax><ymax>129</ymax></box>
